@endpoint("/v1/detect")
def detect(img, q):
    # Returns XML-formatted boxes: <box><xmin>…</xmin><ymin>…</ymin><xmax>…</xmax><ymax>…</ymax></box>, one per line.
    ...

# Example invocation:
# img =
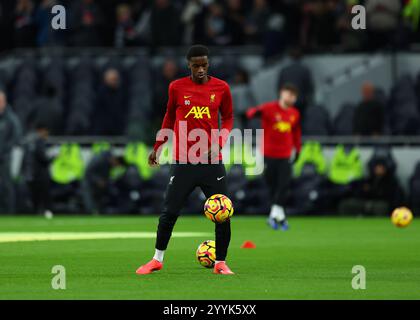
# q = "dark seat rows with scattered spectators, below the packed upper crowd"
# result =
<box><xmin>0</xmin><ymin>49</ymin><xmax>420</xmax><ymax>144</ymax></box>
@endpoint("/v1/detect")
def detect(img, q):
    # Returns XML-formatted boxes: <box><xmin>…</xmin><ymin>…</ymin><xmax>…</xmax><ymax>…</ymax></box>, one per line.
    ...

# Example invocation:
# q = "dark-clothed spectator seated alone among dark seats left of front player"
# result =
<box><xmin>92</xmin><ymin>68</ymin><xmax>127</xmax><ymax>136</ymax></box>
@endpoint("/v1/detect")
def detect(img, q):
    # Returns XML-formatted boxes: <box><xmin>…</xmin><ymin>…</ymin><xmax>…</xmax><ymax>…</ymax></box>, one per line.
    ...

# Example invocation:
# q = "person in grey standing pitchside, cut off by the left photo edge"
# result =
<box><xmin>0</xmin><ymin>91</ymin><xmax>22</xmax><ymax>213</ymax></box>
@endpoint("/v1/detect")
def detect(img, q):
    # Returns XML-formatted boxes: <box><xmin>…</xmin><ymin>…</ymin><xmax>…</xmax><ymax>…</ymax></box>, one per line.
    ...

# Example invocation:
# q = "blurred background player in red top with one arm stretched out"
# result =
<box><xmin>246</xmin><ymin>84</ymin><xmax>301</xmax><ymax>230</ymax></box>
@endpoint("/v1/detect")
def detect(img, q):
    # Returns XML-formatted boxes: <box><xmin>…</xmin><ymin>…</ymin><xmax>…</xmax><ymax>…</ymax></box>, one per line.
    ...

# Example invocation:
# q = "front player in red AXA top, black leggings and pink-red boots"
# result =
<box><xmin>136</xmin><ymin>45</ymin><xmax>233</xmax><ymax>274</ymax></box>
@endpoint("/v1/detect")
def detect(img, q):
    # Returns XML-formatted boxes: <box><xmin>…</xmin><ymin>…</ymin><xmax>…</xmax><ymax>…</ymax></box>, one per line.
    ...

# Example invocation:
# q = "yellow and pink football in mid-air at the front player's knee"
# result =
<box><xmin>204</xmin><ymin>194</ymin><xmax>233</xmax><ymax>223</ymax></box>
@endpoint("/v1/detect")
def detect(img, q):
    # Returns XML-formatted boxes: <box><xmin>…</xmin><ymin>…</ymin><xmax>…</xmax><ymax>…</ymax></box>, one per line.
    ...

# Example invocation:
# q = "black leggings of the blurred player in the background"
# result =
<box><xmin>264</xmin><ymin>157</ymin><xmax>292</xmax><ymax>206</ymax></box>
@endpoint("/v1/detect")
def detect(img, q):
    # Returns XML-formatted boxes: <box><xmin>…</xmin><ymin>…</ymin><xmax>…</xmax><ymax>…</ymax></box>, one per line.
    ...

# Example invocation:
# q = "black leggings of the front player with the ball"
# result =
<box><xmin>156</xmin><ymin>164</ymin><xmax>231</xmax><ymax>260</ymax></box>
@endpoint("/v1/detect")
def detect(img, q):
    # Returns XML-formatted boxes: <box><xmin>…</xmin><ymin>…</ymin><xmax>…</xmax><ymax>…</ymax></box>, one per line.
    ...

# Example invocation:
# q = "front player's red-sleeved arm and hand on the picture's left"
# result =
<box><xmin>148</xmin><ymin>82</ymin><xmax>176</xmax><ymax>166</ymax></box>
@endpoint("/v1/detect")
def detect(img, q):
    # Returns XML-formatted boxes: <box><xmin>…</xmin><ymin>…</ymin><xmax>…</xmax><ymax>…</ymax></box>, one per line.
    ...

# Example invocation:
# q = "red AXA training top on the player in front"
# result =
<box><xmin>154</xmin><ymin>76</ymin><xmax>233</xmax><ymax>162</ymax></box>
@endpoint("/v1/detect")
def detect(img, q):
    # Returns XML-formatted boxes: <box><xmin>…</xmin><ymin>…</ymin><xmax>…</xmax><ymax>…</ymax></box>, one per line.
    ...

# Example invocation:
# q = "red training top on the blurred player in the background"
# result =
<box><xmin>246</xmin><ymin>101</ymin><xmax>301</xmax><ymax>159</ymax></box>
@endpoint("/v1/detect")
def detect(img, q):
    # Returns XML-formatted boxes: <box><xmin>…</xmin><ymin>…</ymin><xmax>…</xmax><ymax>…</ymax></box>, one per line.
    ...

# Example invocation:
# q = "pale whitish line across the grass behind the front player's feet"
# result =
<box><xmin>0</xmin><ymin>232</ymin><xmax>209</xmax><ymax>243</ymax></box>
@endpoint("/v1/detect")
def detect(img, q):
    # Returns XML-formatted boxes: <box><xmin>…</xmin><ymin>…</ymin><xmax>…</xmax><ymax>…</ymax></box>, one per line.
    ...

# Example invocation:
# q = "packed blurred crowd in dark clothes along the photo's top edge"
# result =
<box><xmin>0</xmin><ymin>0</ymin><xmax>420</xmax><ymax>56</ymax></box>
